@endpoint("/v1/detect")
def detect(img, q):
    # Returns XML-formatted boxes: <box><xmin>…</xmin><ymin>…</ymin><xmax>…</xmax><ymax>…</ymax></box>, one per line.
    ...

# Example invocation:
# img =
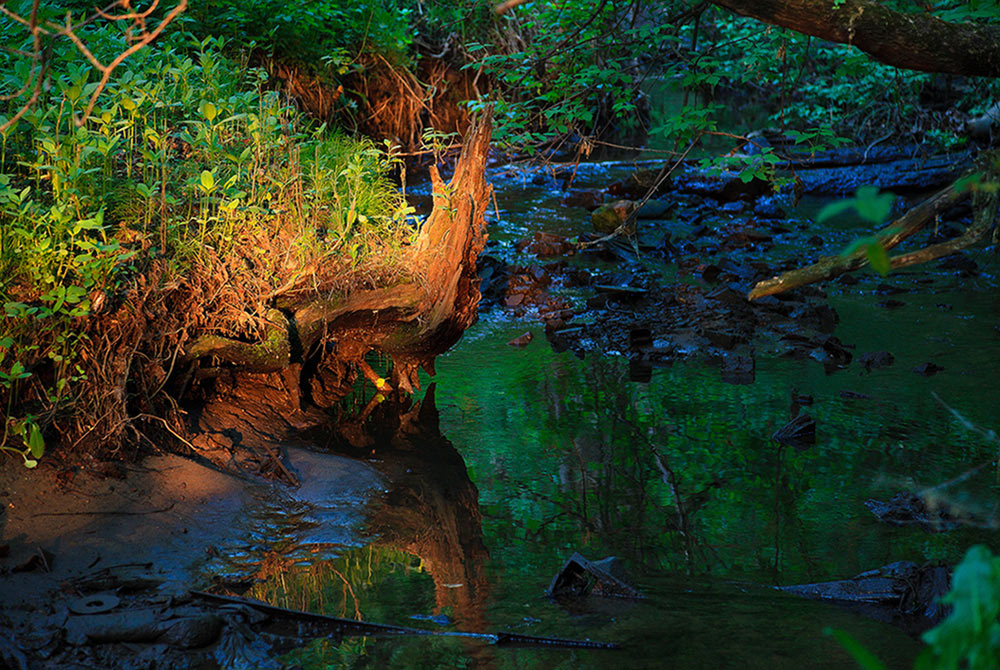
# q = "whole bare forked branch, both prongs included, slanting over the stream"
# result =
<box><xmin>747</xmin><ymin>177</ymin><xmax>976</xmax><ymax>300</ymax></box>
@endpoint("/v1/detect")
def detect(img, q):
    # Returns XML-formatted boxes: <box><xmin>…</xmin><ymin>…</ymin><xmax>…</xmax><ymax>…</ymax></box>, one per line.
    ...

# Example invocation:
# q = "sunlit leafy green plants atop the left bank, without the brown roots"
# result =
<box><xmin>0</xmin><ymin>23</ymin><xmax>413</xmax><ymax>463</ymax></box>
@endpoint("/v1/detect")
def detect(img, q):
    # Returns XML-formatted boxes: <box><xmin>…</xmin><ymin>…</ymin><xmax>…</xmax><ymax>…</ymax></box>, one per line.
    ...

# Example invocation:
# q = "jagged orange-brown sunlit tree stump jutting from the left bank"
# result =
<box><xmin>185</xmin><ymin>111</ymin><xmax>492</xmax><ymax>392</ymax></box>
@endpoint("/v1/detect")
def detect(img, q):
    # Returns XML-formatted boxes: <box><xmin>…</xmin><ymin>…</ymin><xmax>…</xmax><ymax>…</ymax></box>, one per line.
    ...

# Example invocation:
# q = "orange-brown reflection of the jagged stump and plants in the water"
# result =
<box><xmin>248</xmin><ymin>385</ymin><xmax>492</xmax><ymax>668</ymax></box>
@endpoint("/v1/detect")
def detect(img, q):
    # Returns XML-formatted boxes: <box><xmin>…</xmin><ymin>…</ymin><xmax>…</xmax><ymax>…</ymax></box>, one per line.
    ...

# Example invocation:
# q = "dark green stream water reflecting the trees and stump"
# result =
<box><xmin>215</xmin><ymin>158</ymin><xmax>1000</xmax><ymax>668</ymax></box>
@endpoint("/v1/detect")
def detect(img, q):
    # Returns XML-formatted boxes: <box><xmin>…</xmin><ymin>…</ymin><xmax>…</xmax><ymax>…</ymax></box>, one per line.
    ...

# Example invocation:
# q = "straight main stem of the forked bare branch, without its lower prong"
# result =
<box><xmin>747</xmin><ymin>178</ymin><xmax>974</xmax><ymax>300</ymax></box>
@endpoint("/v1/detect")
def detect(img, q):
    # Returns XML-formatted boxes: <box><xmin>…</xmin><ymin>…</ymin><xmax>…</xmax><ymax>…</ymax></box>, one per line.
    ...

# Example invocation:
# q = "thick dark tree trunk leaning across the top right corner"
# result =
<box><xmin>711</xmin><ymin>0</ymin><xmax>1000</xmax><ymax>77</ymax></box>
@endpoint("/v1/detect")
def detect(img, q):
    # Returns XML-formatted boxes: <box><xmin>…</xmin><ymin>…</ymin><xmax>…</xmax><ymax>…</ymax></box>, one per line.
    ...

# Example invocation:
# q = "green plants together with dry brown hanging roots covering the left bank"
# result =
<box><xmin>0</xmin><ymin>3</ymin><xmax>488</xmax><ymax>467</ymax></box>
